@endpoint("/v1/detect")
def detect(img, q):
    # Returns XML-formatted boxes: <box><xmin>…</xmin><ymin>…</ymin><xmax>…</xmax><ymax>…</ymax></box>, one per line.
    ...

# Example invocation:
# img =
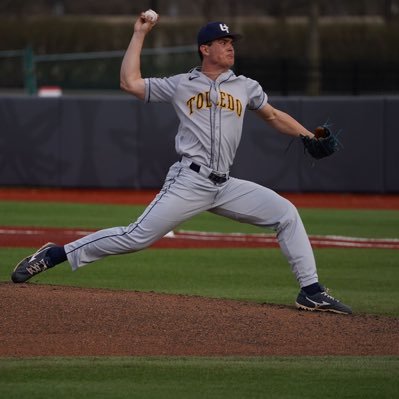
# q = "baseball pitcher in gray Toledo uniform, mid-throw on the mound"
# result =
<box><xmin>11</xmin><ymin>10</ymin><xmax>352</xmax><ymax>314</ymax></box>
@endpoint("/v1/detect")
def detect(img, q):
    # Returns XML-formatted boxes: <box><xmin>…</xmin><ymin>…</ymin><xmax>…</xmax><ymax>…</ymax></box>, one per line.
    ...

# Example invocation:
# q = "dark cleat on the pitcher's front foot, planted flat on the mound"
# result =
<box><xmin>295</xmin><ymin>290</ymin><xmax>352</xmax><ymax>314</ymax></box>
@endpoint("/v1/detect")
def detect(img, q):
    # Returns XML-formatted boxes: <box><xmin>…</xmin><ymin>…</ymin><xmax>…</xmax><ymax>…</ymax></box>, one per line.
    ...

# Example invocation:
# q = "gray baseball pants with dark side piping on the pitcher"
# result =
<box><xmin>65</xmin><ymin>162</ymin><xmax>318</xmax><ymax>287</ymax></box>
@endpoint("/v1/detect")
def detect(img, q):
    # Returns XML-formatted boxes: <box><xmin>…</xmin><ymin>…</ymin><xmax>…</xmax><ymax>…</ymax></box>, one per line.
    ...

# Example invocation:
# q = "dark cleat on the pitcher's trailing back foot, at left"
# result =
<box><xmin>11</xmin><ymin>242</ymin><xmax>55</xmax><ymax>283</ymax></box>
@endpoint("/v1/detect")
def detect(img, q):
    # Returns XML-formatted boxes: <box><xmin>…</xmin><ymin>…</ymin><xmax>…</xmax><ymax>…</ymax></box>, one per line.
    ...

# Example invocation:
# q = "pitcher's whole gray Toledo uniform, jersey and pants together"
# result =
<box><xmin>65</xmin><ymin>68</ymin><xmax>318</xmax><ymax>287</ymax></box>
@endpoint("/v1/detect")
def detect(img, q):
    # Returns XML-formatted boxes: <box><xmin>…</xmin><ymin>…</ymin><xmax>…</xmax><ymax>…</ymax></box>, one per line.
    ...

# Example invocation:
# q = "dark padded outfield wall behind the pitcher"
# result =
<box><xmin>0</xmin><ymin>95</ymin><xmax>399</xmax><ymax>193</ymax></box>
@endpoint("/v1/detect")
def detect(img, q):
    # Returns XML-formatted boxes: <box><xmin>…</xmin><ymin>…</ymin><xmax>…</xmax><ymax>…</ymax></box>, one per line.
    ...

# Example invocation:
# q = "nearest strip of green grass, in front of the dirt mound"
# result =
<box><xmin>0</xmin><ymin>357</ymin><xmax>399</xmax><ymax>399</ymax></box>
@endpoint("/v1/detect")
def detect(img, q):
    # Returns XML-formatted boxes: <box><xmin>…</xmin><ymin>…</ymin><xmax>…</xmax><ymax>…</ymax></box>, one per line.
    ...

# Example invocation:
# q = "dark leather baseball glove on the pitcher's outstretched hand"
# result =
<box><xmin>300</xmin><ymin>125</ymin><xmax>338</xmax><ymax>159</ymax></box>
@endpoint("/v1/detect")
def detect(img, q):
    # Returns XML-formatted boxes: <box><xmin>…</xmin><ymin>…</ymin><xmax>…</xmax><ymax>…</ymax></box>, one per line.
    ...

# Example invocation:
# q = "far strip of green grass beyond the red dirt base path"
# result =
<box><xmin>0</xmin><ymin>201</ymin><xmax>399</xmax><ymax>238</ymax></box>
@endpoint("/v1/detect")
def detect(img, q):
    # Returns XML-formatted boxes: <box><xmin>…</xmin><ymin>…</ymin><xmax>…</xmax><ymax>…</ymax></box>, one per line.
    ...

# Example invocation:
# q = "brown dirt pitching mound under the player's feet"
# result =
<box><xmin>0</xmin><ymin>283</ymin><xmax>399</xmax><ymax>356</ymax></box>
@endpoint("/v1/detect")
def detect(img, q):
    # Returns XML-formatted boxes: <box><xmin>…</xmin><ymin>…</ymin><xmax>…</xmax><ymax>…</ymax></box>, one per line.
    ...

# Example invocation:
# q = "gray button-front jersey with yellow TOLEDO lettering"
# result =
<box><xmin>145</xmin><ymin>69</ymin><xmax>267</xmax><ymax>172</ymax></box>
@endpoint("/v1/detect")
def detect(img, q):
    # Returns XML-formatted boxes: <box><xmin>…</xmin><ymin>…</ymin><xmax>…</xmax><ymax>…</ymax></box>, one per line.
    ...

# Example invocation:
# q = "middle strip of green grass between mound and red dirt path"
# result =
<box><xmin>0</xmin><ymin>248</ymin><xmax>399</xmax><ymax>316</ymax></box>
